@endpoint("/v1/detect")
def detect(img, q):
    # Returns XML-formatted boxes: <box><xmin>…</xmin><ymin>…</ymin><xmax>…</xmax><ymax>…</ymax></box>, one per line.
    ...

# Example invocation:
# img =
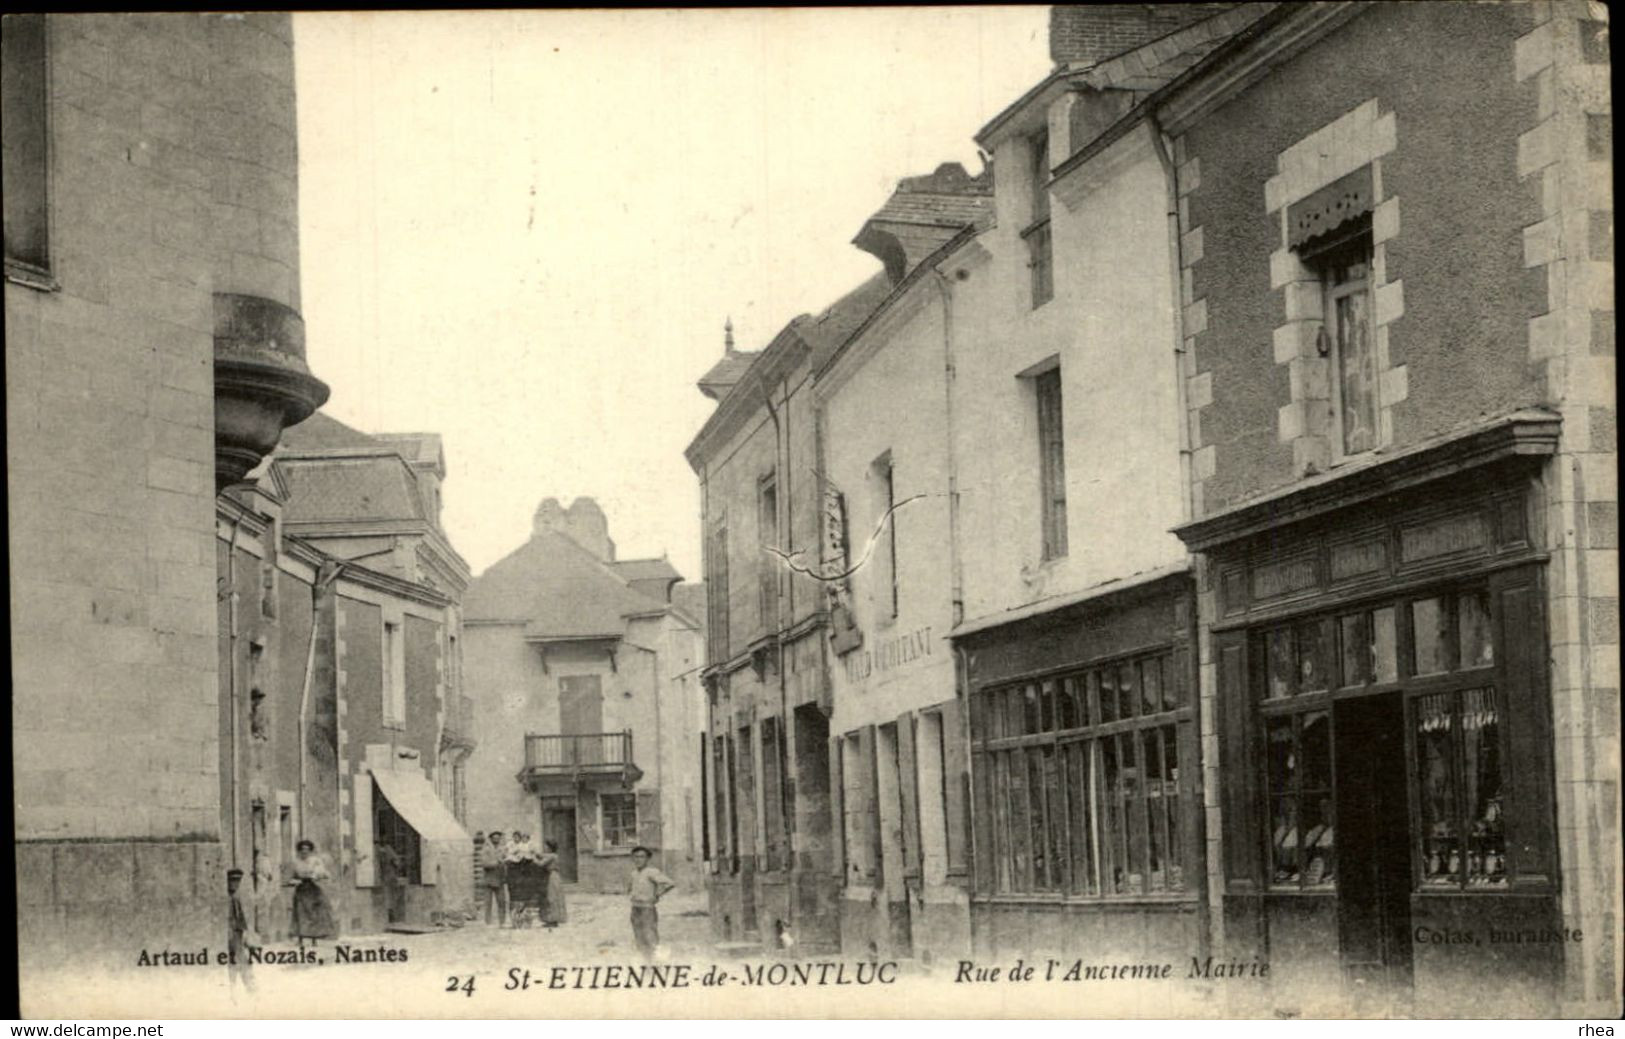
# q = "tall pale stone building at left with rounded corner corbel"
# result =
<box><xmin>3</xmin><ymin>15</ymin><xmax>327</xmax><ymax>993</ymax></box>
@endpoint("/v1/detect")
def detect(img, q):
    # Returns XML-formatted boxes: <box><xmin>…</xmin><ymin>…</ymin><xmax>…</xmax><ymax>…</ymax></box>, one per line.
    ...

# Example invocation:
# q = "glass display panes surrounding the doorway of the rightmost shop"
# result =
<box><xmin>1253</xmin><ymin>589</ymin><xmax>1508</xmax><ymax>891</ymax></box>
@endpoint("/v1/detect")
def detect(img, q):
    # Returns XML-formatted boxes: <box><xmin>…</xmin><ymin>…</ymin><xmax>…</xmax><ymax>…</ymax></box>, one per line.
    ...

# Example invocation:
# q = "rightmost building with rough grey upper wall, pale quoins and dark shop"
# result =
<box><xmin>1154</xmin><ymin>3</ymin><xmax>1620</xmax><ymax>1016</ymax></box>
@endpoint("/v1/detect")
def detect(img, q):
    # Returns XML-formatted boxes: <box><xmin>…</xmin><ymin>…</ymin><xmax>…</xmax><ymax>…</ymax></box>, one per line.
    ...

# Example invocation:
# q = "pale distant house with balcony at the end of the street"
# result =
<box><xmin>463</xmin><ymin>498</ymin><xmax>705</xmax><ymax>893</ymax></box>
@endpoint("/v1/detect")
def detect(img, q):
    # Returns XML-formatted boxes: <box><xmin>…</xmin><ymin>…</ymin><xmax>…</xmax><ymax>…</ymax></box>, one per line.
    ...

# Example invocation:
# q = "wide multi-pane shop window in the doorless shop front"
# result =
<box><xmin>972</xmin><ymin>652</ymin><xmax>1193</xmax><ymax>898</ymax></box>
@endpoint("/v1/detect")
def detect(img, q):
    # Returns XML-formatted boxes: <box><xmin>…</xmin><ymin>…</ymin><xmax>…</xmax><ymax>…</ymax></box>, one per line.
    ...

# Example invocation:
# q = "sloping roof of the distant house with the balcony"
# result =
<box><xmin>463</xmin><ymin>530</ymin><xmax>676</xmax><ymax>639</ymax></box>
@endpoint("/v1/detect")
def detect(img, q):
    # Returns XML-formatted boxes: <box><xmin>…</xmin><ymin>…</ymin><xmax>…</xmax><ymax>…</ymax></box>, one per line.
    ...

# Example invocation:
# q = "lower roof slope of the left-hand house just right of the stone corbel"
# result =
<box><xmin>276</xmin><ymin>454</ymin><xmax>424</xmax><ymax>524</ymax></box>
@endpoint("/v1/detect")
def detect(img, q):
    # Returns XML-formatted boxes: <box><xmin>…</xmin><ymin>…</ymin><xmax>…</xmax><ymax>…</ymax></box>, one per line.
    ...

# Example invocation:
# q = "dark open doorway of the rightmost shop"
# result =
<box><xmin>1336</xmin><ymin>693</ymin><xmax>1411</xmax><ymax>1000</ymax></box>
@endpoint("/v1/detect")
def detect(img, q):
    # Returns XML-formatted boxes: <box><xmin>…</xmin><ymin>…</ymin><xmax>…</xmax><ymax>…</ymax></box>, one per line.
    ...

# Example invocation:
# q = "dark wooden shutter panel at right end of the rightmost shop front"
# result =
<box><xmin>1490</xmin><ymin>566</ymin><xmax>1557</xmax><ymax>889</ymax></box>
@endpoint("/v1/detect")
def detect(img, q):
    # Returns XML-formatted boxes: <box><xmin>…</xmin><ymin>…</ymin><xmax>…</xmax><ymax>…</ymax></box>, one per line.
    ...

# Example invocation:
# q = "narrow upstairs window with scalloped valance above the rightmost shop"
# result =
<box><xmin>1305</xmin><ymin>224</ymin><xmax>1378</xmax><ymax>455</ymax></box>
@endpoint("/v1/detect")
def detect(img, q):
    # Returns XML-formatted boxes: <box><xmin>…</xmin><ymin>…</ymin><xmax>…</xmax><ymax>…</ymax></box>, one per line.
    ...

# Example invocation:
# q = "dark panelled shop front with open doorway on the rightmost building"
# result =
<box><xmin>1180</xmin><ymin>416</ymin><xmax>1567</xmax><ymax>1016</ymax></box>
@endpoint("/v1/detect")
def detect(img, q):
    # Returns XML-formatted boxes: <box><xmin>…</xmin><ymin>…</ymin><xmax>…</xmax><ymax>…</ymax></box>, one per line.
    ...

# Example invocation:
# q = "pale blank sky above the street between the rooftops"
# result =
<box><xmin>294</xmin><ymin>7</ymin><xmax>1050</xmax><ymax>579</ymax></box>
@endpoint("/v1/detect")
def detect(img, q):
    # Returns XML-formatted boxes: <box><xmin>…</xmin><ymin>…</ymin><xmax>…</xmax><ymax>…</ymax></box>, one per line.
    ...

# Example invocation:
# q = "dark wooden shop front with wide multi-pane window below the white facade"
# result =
<box><xmin>956</xmin><ymin>567</ymin><xmax>1207</xmax><ymax>964</ymax></box>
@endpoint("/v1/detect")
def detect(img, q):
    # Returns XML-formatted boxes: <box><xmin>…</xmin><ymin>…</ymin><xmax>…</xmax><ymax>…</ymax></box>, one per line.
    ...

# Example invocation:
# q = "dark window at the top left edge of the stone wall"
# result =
<box><xmin>0</xmin><ymin>15</ymin><xmax>50</xmax><ymax>285</ymax></box>
